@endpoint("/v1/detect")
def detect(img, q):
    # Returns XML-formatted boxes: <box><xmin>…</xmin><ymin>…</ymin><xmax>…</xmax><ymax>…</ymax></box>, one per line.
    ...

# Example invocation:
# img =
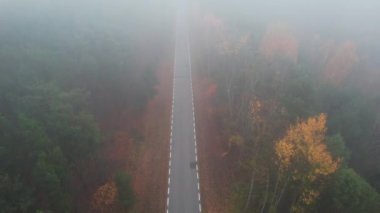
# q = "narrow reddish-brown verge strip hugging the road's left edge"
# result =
<box><xmin>130</xmin><ymin>60</ymin><xmax>173</xmax><ymax>212</ymax></box>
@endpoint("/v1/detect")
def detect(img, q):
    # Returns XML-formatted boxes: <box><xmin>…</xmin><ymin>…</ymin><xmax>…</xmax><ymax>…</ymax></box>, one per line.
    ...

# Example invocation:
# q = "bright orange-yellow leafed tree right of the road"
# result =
<box><xmin>274</xmin><ymin>114</ymin><xmax>340</xmax><ymax>212</ymax></box>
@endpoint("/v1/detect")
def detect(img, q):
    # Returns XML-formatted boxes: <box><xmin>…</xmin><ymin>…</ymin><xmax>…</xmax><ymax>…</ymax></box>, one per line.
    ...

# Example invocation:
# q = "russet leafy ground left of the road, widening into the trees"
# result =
<box><xmin>100</xmin><ymin>55</ymin><xmax>173</xmax><ymax>213</ymax></box>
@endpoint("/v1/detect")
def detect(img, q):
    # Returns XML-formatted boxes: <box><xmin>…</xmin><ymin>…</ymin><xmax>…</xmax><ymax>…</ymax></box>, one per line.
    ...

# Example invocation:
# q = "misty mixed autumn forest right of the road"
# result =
<box><xmin>191</xmin><ymin>0</ymin><xmax>380</xmax><ymax>212</ymax></box>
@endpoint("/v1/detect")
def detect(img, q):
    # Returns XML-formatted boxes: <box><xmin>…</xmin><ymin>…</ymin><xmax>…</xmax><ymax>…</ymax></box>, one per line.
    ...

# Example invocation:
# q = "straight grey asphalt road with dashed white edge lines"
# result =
<box><xmin>167</xmin><ymin>2</ymin><xmax>201</xmax><ymax>213</ymax></box>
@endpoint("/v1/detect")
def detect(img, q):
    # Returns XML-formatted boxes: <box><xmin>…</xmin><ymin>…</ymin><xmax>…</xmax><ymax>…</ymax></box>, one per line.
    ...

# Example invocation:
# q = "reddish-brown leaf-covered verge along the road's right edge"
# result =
<box><xmin>193</xmin><ymin>74</ymin><xmax>231</xmax><ymax>213</ymax></box>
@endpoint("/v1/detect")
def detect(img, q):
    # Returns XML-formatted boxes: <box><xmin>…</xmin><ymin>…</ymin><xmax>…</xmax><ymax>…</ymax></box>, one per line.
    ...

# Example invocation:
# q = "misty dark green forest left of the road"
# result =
<box><xmin>0</xmin><ymin>0</ymin><xmax>173</xmax><ymax>213</ymax></box>
